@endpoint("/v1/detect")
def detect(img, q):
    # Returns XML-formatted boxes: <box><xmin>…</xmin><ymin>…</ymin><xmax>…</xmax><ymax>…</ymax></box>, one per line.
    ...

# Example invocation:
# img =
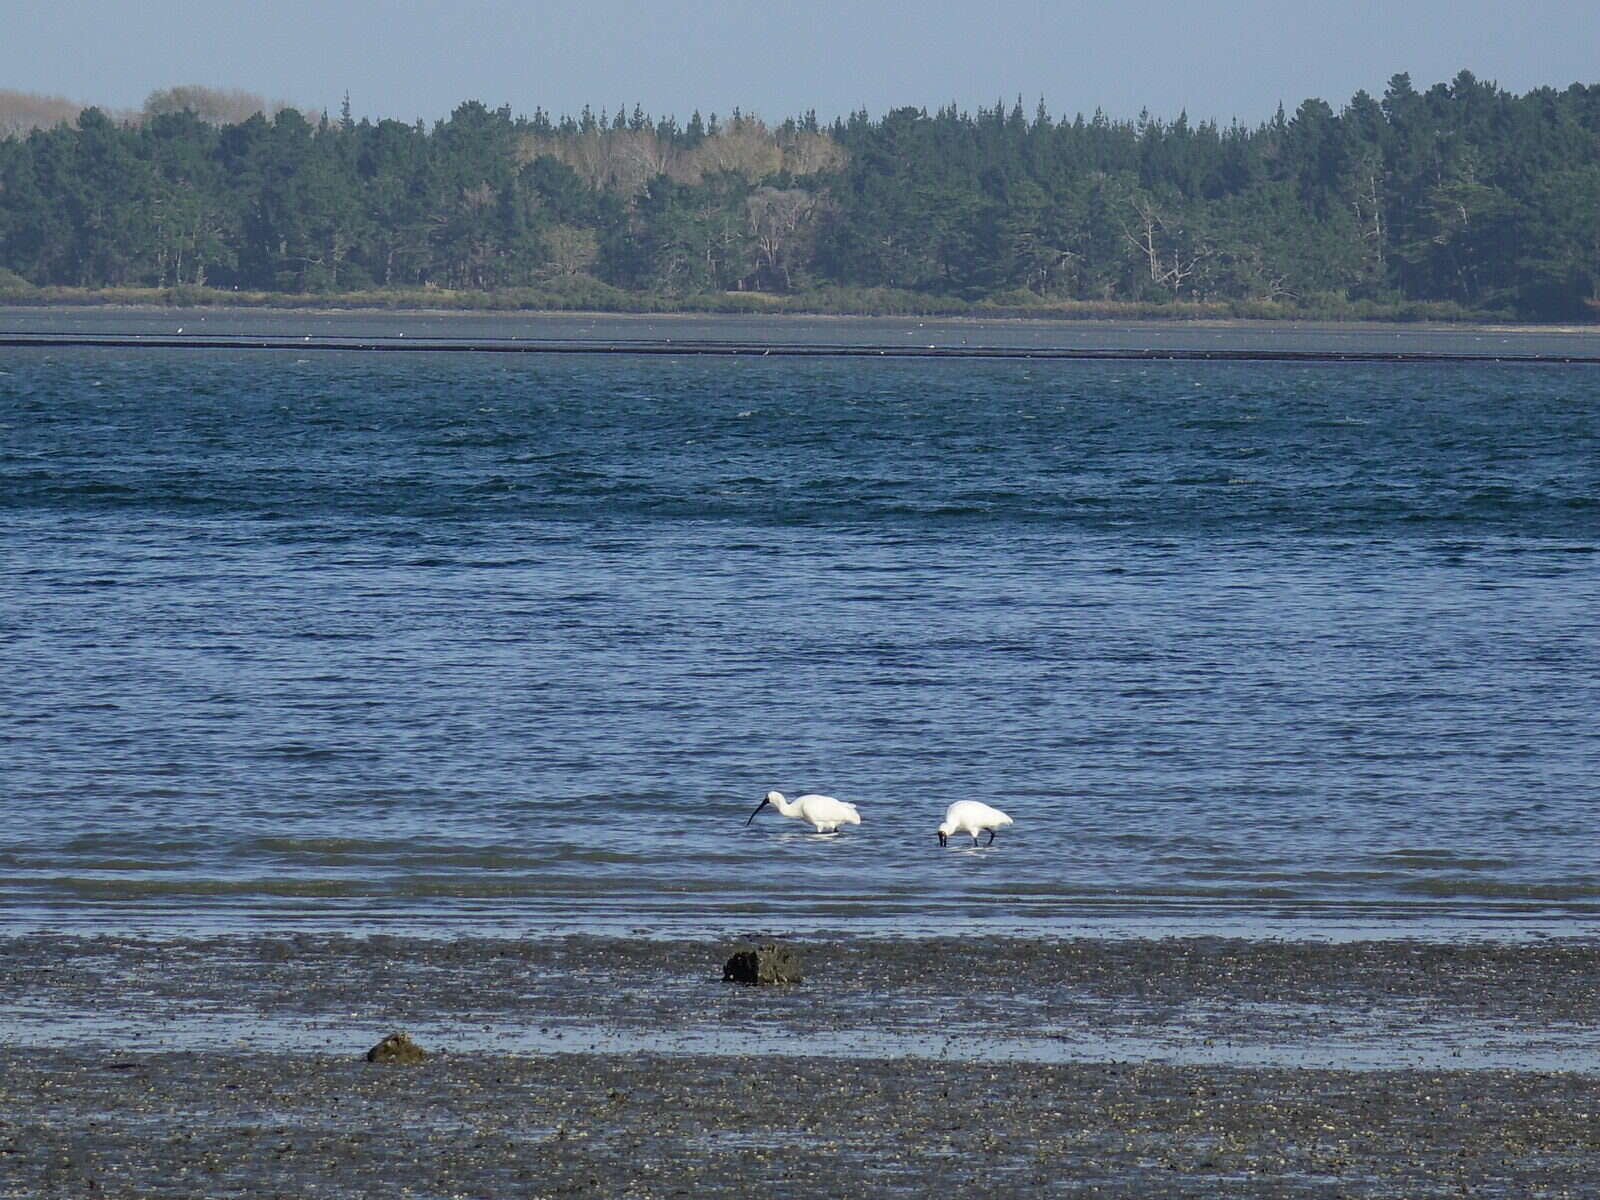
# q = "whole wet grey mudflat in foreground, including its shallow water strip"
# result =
<box><xmin>0</xmin><ymin>936</ymin><xmax>1600</xmax><ymax>1197</ymax></box>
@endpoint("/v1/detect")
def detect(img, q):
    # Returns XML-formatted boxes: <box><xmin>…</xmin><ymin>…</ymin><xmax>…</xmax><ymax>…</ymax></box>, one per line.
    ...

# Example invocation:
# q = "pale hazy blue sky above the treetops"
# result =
<box><xmin>9</xmin><ymin>0</ymin><xmax>1600</xmax><ymax>125</ymax></box>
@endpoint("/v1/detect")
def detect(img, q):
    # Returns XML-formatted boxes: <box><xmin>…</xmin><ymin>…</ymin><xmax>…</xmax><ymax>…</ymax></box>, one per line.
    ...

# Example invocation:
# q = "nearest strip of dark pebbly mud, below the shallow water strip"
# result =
<box><xmin>0</xmin><ymin>1050</ymin><xmax>1600</xmax><ymax>1197</ymax></box>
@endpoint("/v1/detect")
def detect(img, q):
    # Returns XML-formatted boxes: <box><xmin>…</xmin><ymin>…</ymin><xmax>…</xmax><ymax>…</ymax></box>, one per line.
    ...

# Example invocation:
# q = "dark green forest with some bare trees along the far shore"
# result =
<box><xmin>0</xmin><ymin>72</ymin><xmax>1600</xmax><ymax>318</ymax></box>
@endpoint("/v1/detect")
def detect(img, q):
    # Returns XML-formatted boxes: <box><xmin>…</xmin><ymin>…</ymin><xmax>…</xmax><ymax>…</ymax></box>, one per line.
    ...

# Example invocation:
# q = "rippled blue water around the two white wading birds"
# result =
<box><xmin>0</xmin><ymin>326</ymin><xmax>1600</xmax><ymax>933</ymax></box>
